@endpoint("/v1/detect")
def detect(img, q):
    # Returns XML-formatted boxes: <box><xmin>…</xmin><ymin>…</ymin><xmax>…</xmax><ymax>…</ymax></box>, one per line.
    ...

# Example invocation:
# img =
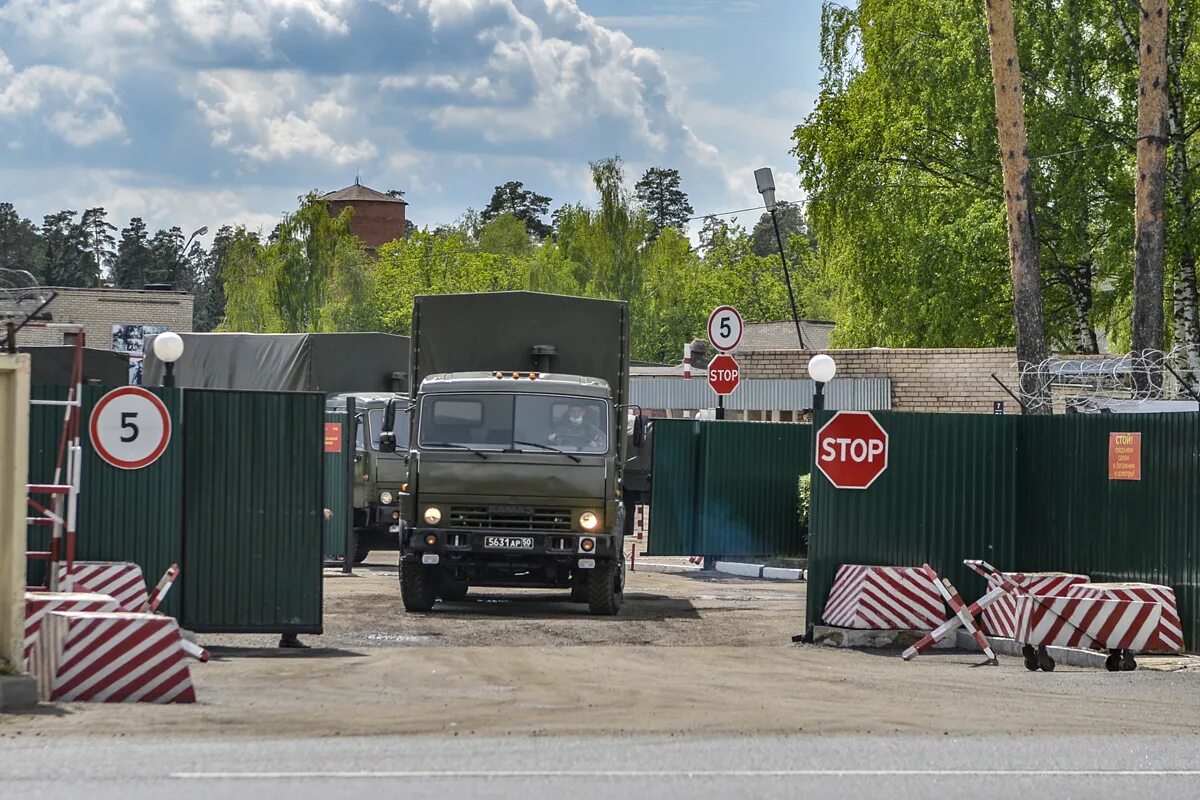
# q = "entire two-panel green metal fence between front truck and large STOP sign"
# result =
<box><xmin>649</xmin><ymin>420</ymin><xmax>812</xmax><ymax>557</ymax></box>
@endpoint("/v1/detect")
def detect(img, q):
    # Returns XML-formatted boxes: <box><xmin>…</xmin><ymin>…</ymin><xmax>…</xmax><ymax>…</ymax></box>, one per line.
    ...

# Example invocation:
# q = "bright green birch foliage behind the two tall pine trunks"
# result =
<box><xmin>794</xmin><ymin>0</ymin><xmax>1200</xmax><ymax>351</ymax></box>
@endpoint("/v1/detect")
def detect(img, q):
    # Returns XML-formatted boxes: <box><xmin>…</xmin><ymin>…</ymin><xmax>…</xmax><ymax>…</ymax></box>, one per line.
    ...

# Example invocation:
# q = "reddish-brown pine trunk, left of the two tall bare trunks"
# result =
<box><xmin>985</xmin><ymin>0</ymin><xmax>1050</xmax><ymax>414</ymax></box>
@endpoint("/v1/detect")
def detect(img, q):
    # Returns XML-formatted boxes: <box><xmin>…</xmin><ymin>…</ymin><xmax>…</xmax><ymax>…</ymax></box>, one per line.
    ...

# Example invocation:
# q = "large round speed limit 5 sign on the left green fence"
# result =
<box><xmin>88</xmin><ymin>386</ymin><xmax>170</xmax><ymax>469</ymax></box>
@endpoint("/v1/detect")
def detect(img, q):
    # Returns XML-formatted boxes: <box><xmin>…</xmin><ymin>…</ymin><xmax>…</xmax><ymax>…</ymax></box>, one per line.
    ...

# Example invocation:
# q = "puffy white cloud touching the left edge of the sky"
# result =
<box><xmin>0</xmin><ymin>50</ymin><xmax>125</xmax><ymax>148</ymax></box>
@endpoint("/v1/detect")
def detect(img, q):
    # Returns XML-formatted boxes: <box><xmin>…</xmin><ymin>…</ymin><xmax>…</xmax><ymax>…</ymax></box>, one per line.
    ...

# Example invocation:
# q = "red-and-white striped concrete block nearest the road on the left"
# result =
<box><xmin>34</xmin><ymin>612</ymin><xmax>196</xmax><ymax>703</ymax></box>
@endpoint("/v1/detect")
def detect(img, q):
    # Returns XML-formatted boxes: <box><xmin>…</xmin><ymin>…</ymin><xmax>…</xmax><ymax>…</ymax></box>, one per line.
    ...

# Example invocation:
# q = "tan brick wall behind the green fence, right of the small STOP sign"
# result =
<box><xmin>737</xmin><ymin>348</ymin><xmax>1020</xmax><ymax>414</ymax></box>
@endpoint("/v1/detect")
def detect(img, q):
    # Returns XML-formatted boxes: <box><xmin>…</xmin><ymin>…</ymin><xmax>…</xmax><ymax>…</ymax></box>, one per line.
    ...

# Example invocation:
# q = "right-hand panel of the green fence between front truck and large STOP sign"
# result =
<box><xmin>696</xmin><ymin>422</ymin><xmax>812</xmax><ymax>557</ymax></box>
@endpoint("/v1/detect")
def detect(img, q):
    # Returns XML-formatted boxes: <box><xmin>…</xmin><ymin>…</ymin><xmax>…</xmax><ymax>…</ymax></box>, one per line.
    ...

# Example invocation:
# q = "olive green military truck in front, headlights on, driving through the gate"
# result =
<box><xmin>383</xmin><ymin>291</ymin><xmax>644</xmax><ymax>615</ymax></box>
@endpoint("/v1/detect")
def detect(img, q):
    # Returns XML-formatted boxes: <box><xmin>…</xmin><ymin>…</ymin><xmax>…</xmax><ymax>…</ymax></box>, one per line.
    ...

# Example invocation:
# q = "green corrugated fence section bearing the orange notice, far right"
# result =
<box><xmin>1015</xmin><ymin>414</ymin><xmax>1200</xmax><ymax>650</ymax></box>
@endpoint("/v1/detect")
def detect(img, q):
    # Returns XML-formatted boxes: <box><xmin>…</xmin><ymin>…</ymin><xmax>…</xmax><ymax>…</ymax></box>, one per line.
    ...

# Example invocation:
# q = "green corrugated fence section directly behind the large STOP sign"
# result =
<box><xmin>801</xmin><ymin>411</ymin><xmax>1020</xmax><ymax>625</ymax></box>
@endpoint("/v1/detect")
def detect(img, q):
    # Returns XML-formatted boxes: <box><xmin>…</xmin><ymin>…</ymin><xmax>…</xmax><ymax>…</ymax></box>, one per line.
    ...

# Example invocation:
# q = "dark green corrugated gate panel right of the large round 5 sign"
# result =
<box><xmin>181</xmin><ymin>390</ymin><xmax>325</xmax><ymax>633</ymax></box>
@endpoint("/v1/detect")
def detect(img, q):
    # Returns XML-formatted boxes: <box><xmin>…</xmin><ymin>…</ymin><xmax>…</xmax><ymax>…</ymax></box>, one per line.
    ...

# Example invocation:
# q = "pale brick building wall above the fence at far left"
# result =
<box><xmin>17</xmin><ymin>289</ymin><xmax>192</xmax><ymax>350</ymax></box>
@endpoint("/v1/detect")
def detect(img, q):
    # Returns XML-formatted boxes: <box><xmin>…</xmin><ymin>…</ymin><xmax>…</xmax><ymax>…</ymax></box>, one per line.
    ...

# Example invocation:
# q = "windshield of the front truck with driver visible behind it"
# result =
<box><xmin>420</xmin><ymin>393</ymin><xmax>608</xmax><ymax>453</ymax></box>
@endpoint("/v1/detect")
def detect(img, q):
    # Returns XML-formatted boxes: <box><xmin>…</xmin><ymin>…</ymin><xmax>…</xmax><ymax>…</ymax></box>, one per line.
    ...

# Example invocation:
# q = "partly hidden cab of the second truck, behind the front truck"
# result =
<box><xmin>325</xmin><ymin>392</ymin><xmax>408</xmax><ymax>564</ymax></box>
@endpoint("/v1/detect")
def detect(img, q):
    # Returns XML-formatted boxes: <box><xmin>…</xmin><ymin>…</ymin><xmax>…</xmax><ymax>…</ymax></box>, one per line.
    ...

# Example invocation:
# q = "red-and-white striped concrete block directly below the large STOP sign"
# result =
<box><xmin>822</xmin><ymin>564</ymin><xmax>946</xmax><ymax>631</ymax></box>
